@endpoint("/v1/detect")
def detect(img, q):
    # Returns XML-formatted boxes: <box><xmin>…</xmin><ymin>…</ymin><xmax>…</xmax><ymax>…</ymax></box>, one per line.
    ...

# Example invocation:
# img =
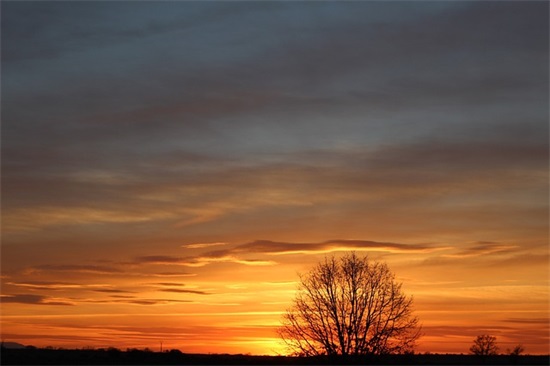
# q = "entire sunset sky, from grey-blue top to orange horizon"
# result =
<box><xmin>0</xmin><ymin>1</ymin><xmax>550</xmax><ymax>354</ymax></box>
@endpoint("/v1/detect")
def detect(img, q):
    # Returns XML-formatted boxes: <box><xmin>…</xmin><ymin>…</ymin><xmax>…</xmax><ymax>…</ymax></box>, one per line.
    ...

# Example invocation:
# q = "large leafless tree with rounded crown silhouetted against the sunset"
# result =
<box><xmin>279</xmin><ymin>253</ymin><xmax>420</xmax><ymax>356</ymax></box>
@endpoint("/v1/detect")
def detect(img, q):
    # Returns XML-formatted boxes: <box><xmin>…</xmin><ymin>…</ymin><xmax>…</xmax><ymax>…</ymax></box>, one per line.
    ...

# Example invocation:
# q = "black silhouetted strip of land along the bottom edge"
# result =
<box><xmin>0</xmin><ymin>347</ymin><xmax>550</xmax><ymax>365</ymax></box>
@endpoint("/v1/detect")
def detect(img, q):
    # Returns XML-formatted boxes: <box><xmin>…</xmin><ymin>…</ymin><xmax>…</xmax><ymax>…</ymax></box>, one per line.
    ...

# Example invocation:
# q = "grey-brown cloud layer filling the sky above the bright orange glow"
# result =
<box><xmin>2</xmin><ymin>2</ymin><xmax>549</xmax><ymax>294</ymax></box>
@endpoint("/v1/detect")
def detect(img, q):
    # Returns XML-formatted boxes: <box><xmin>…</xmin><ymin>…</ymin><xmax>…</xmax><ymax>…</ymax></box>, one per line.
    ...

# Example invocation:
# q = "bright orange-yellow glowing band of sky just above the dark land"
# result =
<box><xmin>2</xmin><ymin>243</ymin><xmax>547</xmax><ymax>354</ymax></box>
